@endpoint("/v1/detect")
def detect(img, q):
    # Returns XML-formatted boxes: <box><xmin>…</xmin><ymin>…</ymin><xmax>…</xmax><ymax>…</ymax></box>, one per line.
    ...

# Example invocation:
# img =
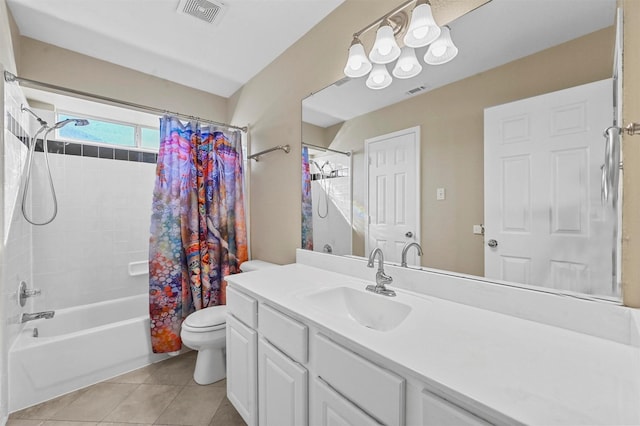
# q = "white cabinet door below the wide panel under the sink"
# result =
<box><xmin>311</xmin><ymin>377</ymin><xmax>380</xmax><ymax>426</ymax></box>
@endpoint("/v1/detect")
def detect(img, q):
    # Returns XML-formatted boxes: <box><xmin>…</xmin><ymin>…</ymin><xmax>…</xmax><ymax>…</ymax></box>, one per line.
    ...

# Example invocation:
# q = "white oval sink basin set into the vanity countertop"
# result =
<box><xmin>302</xmin><ymin>287</ymin><xmax>411</xmax><ymax>331</ymax></box>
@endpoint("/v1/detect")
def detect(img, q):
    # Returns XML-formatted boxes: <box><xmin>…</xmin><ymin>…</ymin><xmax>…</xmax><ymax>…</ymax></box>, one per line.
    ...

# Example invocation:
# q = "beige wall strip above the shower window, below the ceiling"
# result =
<box><xmin>16</xmin><ymin>37</ymin><xmax>227</xmax><ymax>122</ymax></box>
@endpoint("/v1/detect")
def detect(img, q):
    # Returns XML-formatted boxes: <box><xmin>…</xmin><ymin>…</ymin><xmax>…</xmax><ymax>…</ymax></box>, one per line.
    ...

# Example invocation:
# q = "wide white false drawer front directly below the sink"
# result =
<box><xmin>314</xmin><ymin>335</ymin><xmax>405</xmax><ymax>426</ymax></box>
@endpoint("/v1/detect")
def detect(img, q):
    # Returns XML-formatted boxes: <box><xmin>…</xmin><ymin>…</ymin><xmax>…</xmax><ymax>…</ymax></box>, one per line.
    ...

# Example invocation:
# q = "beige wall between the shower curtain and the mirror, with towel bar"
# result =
<box><xmin>229</xmin><ymin>0</ymin><xmax>393</xmax><ymax>263</ymax></box>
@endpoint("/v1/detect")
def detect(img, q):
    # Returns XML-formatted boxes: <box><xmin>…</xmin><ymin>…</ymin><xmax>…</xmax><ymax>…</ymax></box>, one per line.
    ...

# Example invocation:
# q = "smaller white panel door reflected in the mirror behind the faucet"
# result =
<box><xmin>365</xmin><ymin>127</ymin><xmax>420</xmax><ymax>265</ymax></box>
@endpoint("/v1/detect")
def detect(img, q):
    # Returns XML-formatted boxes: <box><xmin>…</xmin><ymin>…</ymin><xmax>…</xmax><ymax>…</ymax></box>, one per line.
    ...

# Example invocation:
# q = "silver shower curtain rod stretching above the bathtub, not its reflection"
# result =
<box><xmin>4</xmin><ymin>71</ymin><xmax>249</xmax><ymax>133</ymax></box>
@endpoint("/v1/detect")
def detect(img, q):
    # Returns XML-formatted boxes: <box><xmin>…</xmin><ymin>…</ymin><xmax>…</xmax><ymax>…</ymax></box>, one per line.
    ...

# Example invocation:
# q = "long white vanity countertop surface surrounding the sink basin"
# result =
<box><xmin>227</xmin><ymin>264</ymin><xmax>640</xmax><ymax>425</ymax></box>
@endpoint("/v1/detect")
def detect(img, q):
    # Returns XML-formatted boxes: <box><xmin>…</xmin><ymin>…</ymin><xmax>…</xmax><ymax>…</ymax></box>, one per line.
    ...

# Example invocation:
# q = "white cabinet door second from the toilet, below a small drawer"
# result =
<box><xmin>258</xmin><ymin>338</ymin><xmax>309</xmax><ymax>426</ymax></box>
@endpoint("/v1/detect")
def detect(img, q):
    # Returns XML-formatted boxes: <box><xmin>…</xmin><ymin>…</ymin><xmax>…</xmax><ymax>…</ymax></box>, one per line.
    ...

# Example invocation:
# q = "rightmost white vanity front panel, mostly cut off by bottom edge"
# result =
<box><xmin>421</xmin><ymin>390</ymin><xmax>490</xmax><ymax>426</ymax></box>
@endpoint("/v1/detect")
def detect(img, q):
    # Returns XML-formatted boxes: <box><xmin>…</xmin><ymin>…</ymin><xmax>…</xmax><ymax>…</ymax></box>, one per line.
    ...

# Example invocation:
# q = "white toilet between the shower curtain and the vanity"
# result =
<box><xmin>180</xmin><ymin>260</ymin><xmax>277</xmax><ymax>385</ymax></box>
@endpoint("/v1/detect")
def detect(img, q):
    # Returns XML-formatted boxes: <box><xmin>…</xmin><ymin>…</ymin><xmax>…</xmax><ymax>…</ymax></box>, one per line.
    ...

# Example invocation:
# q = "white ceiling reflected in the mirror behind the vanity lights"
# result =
<box><xmin>302</xmin><ymin>0</ymin><xmax>616</xmax><ymax>127</ymax></box>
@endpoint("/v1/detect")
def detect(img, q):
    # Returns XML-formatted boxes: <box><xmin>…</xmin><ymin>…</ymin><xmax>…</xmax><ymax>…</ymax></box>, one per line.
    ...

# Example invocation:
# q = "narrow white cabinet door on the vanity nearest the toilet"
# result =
<box><xmin>227</xmin><ymin>315</ymin><xmax>258</xmax><ymax>426</ymax></box>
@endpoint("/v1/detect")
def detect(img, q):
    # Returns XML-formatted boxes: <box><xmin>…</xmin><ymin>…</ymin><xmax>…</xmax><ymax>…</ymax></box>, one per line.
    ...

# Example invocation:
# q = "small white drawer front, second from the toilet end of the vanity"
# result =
<box><xmin>258</xmin><ymin>303</ymin><xmax>309</xmax><ymax>363</ymax></box>
